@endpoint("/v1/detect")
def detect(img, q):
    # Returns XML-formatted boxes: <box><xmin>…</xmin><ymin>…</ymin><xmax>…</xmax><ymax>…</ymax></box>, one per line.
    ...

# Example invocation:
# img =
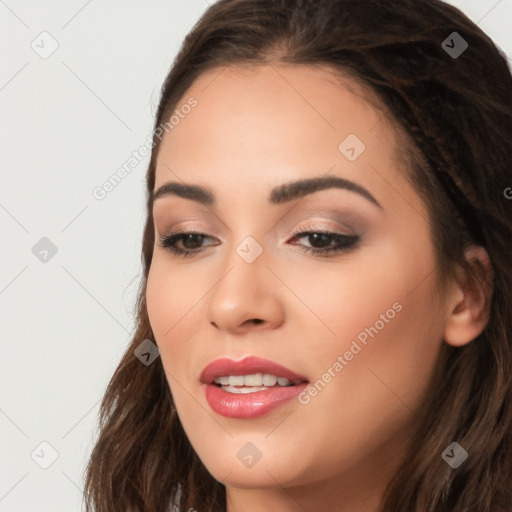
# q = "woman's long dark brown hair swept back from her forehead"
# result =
<box><xmin>84</xmin><ymin>0</ymin><xmax>512</xmax><ymax>512</ymax></box>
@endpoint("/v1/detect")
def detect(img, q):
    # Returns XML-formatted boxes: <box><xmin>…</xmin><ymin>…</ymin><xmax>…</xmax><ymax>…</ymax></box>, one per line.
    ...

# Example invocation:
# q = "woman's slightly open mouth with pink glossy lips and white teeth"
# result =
<box><xmin>200</xmin><ymin>356</ymin><xmax>309</xmax><ymax>419</ymax></box>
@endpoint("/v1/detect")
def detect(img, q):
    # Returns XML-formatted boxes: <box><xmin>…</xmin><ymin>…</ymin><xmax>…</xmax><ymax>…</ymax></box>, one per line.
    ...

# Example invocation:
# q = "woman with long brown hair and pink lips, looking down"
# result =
<box><xmin>86</xmin><ymin>0</ymin><xmax>512</xmax><ymax>512</ymax></box>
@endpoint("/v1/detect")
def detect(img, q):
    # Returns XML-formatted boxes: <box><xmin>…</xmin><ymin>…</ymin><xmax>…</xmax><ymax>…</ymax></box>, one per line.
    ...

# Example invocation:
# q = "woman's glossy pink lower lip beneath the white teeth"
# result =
<box><xmin>203</xmin><ymin>382</ymin><xmax>308</xmax><ymax>419</ymax></box>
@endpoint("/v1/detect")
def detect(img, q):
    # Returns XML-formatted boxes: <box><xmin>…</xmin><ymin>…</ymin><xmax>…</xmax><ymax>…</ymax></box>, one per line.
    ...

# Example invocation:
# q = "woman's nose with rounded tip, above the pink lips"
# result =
<box><xmin>206</xmin><ymin>245</ymin><xmax>285</xmax><ymax>334</ymax></box>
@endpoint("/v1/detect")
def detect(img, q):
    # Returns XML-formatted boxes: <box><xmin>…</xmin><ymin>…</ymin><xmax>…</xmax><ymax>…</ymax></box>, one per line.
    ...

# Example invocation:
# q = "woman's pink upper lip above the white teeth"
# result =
<box><xmin>199</xmin><ymin>356</ymin><xmax>307</xmax><ymax>384</ymax></box>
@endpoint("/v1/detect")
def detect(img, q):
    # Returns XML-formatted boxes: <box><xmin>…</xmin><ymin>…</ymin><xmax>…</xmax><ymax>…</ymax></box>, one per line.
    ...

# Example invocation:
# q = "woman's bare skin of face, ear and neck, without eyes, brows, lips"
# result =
<box><xmin>147</xmin><ymin>64</ymin><xmax>488</xmax><ymax>512</ymax></box>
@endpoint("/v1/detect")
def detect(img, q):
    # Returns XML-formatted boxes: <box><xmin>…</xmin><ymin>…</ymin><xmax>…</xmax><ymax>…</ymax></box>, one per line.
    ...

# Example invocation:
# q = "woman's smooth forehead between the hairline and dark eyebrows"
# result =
<box><xmin>155</xmin><ymin>64</ymin><xmax>404</xmax><ymax>200</ymax></box>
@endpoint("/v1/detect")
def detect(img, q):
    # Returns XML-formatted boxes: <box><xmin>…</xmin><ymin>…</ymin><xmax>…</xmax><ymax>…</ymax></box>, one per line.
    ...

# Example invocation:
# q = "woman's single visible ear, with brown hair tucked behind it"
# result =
<box><xmin>444</xmin><ymin>245</ymin><xmax>494</xmax><ymax>347</ymax></box>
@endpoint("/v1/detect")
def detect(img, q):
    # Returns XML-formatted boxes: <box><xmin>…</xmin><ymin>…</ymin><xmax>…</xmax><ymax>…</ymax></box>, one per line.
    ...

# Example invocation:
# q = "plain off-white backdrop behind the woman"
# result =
<box><xmin>0</xmin><ymin>0</ymin><xmax>512</xmax><ymax>512</ymax></box>
